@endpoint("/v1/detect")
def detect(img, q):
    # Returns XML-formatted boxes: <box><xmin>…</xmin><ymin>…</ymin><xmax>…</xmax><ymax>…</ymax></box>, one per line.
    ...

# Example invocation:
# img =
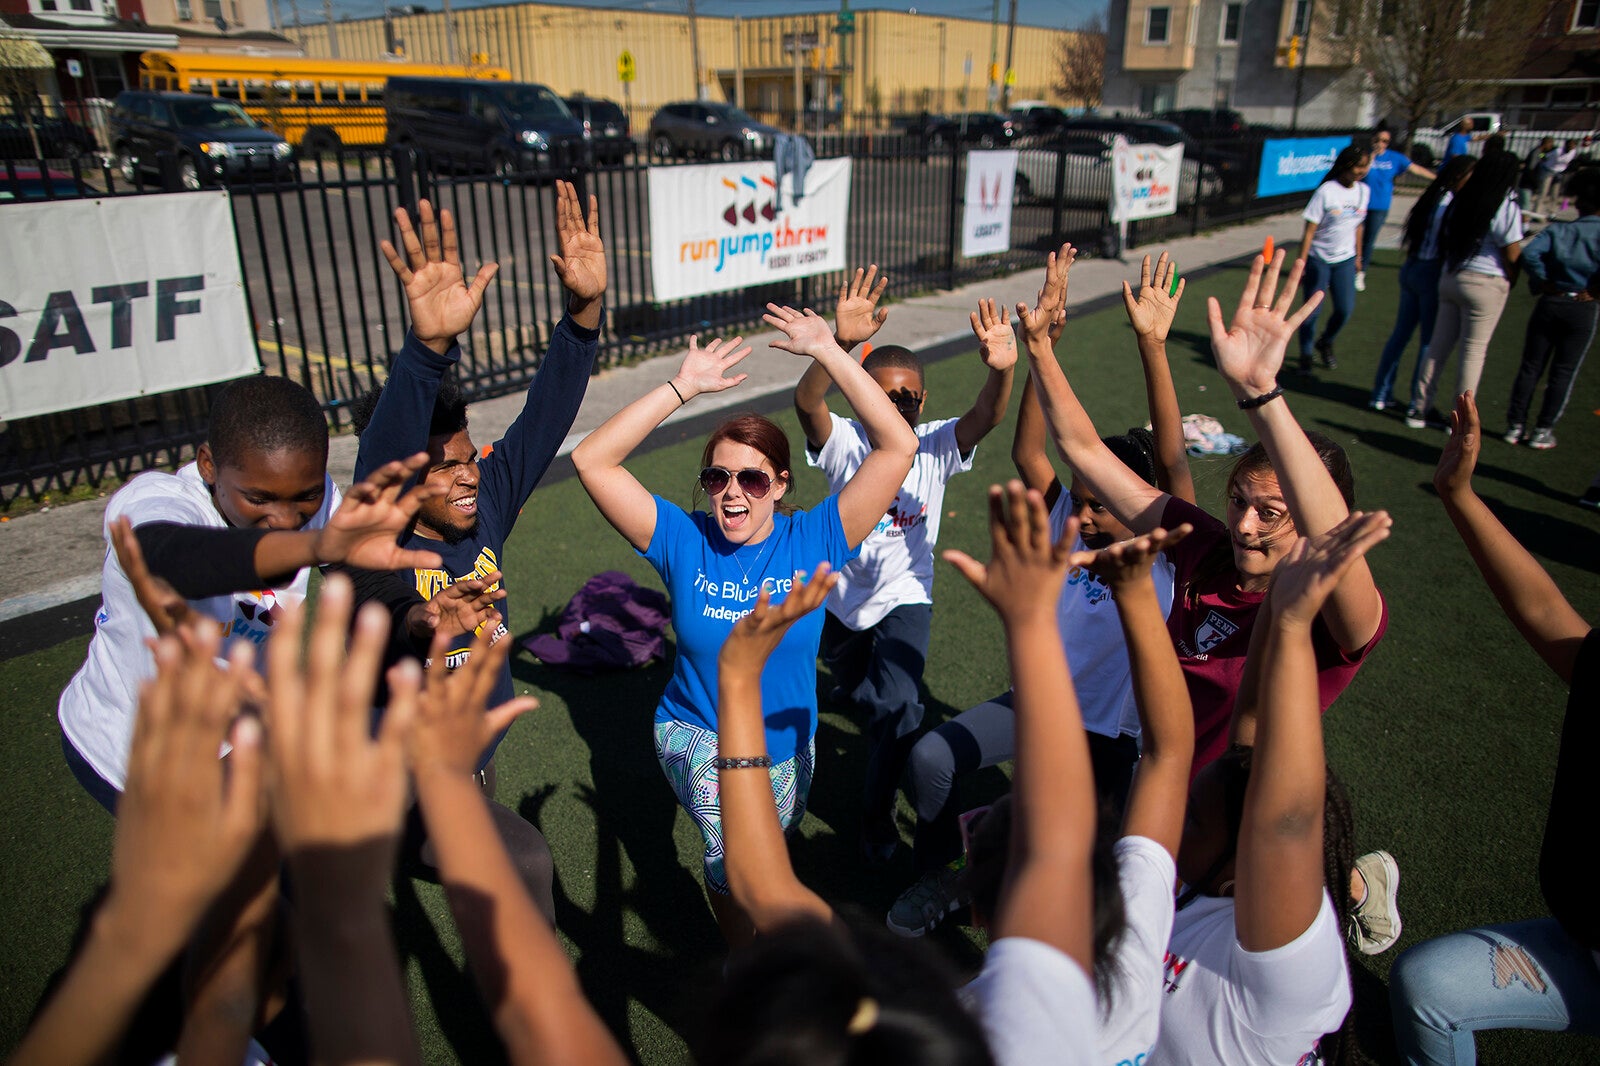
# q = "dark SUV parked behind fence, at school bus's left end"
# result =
<box><xmin>110</xmin><ymin>90</ymin><xmax>298</xmax><ymax>189</ymax></box>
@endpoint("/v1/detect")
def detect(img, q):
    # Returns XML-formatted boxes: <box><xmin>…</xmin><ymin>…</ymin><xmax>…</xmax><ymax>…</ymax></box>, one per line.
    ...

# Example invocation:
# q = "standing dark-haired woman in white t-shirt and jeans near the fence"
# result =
<box><xmin>1298</xmin><ymin>144</ymin><xmax>1373</xmax><ymax>371</ymax></box>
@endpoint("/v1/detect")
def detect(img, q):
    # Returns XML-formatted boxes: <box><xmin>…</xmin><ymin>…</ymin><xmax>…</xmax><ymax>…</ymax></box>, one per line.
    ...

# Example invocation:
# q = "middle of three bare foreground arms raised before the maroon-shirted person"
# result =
<box><xmin>1074</xmin><ymin>523</ymin><xmax>1195</xmax><ymax>858</ymax></box>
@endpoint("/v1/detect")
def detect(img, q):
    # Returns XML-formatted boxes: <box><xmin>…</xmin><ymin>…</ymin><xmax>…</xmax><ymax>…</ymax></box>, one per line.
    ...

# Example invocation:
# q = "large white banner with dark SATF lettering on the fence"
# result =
<box><xmin>0</xmin><ymin>192</ymin><xmax>261</xmax><ymax>419</ymax></box>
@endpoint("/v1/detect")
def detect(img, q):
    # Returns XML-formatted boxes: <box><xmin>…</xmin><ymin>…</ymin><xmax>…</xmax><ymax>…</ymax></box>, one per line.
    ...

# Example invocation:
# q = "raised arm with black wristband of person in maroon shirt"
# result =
<box><xmin>1206</xmin><ymin>251</ymin><xmax>1382</xmax><ymax>651</ymax></box>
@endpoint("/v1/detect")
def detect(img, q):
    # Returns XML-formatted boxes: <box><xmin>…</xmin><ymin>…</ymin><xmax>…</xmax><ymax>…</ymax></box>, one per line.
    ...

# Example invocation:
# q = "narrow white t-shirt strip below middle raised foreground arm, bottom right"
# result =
<box><xmin>1099</xmin><ymin>837</ymin><xmax>1178</xmax><ymax>1066</ymax></box>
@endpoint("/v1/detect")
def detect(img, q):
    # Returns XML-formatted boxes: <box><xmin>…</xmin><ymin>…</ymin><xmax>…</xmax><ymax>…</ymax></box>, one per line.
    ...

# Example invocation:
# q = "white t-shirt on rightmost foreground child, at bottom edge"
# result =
<box><xmin>1150</xmin><ymin>892</ymin><xmax>1350</xmax><ymax>1066</ymax></box>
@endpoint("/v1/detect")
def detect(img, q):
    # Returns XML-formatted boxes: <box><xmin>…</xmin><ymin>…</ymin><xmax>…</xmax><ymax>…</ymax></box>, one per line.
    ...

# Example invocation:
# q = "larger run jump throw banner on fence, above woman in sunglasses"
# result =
<box><xmin>650</xmin><ymin>158</ymin><xmax>850</xmax><ymax>301</ymax></box>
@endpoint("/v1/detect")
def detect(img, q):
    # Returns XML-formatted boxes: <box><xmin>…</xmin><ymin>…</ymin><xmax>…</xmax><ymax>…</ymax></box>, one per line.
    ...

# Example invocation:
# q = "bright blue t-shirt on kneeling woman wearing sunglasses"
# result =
<box><xmin>640</xmin><ymin>496</ymin><xmax>858</xmax><ymax>763</ymax></box>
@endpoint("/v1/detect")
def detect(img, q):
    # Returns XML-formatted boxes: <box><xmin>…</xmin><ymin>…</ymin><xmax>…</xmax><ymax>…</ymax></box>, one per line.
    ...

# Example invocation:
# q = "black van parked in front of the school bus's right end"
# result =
<box><xmin>384</xmin><ymin>77</ymin><xmax>584</xmax><ymax>178</ymax></box>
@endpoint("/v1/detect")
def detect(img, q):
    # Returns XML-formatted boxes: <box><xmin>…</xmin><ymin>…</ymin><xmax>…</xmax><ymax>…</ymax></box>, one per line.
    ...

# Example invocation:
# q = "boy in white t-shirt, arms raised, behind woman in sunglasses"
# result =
<box><xmin>794</xmin><ymin>266</ymin><xmax>1016</xmax><ymax>861</ymax></box>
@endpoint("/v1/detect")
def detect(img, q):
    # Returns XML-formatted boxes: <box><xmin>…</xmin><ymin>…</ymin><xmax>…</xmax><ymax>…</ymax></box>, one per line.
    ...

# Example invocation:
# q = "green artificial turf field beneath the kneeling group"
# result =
<box><xmin>0</xmin><ymin>253</ymin><xmax>1600</xmax><ymax>1063</ymax></box>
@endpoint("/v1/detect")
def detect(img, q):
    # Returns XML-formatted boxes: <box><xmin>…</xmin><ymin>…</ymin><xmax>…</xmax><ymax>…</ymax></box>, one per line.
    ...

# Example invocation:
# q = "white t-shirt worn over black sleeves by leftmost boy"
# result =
<box><xmin>56</xmin><ymin>463</ymin><xmax>341</xmax><ymax>789</ymax></box>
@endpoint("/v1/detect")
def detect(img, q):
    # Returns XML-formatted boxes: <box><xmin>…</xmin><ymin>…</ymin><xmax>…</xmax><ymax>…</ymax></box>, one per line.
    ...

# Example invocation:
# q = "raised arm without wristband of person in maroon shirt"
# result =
<box><xmin>1016</xmin><ymin>245</ymin><xmax>1166</xmax><ymax>533</ymax></box>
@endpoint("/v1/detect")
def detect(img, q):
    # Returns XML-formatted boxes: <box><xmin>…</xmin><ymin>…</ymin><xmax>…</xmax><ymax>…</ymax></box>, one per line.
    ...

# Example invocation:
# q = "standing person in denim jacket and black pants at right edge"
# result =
<box><xmin>1506</xmin><ymin>171</ymin><xmax>1600</xmax><ymax>451</ymax></box>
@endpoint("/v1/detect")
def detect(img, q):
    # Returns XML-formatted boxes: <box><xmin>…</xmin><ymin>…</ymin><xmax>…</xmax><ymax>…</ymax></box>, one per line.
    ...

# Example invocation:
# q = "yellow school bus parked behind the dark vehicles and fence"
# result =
<box><xmin>139</xmin><ymin>51</ymin><xmax>510</xmax><ymax>154</ymax></box>
